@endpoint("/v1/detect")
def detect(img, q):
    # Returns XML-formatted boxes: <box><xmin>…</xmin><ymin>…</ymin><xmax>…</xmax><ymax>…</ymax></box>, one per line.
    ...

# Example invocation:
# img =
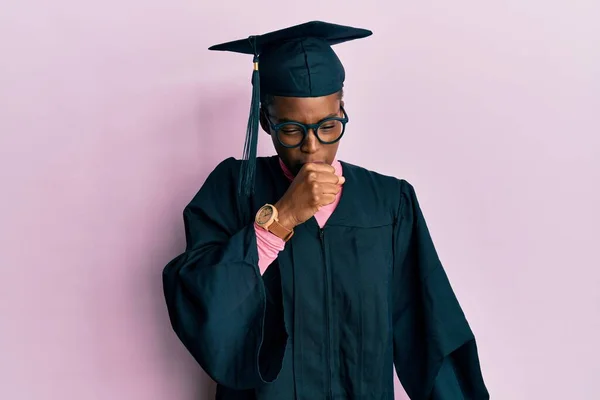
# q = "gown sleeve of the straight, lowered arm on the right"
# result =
<box><xmin>392</xmin><ymin>181</ymin><xmax>489</xmax><ymax>400</ymax></box>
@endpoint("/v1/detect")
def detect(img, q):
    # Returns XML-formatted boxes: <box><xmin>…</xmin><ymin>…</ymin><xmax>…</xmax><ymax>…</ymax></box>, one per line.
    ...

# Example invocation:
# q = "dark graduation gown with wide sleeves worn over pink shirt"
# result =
<box><xmin>163</xmin><ymin>157</ymin><xmax>489</xmax><ymax>400</ymax></box>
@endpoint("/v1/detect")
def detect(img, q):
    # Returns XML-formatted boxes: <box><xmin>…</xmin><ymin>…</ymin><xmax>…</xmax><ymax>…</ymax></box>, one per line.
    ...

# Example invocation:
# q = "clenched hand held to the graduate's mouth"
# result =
<box><xmin>275</xmin><ymin>163</ymin><xmax>346</xmax><ymax>229</ymax></box>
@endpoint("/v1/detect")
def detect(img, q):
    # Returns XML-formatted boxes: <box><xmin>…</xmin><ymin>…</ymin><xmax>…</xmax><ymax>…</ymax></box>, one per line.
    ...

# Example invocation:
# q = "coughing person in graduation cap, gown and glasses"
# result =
<box><xmin>163</xmin><ymin>22</ymin><xmax>489</xmax><ymax>400</ymax></box>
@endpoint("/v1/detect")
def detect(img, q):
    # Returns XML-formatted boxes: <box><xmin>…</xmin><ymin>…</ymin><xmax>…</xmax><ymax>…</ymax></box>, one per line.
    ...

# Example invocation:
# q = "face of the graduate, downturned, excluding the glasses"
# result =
<box><xmin>261</xmin><ymin>93</ymin><xmax>344</xmax><ymax>175</ymax></box>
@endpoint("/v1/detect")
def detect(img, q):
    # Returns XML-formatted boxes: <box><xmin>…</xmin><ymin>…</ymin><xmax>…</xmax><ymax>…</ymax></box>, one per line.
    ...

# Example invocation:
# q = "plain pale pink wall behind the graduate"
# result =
<box><xmin>0</xmin><ymin>0</ymin><xmax>600</xmax><ymax>400</ymax></box>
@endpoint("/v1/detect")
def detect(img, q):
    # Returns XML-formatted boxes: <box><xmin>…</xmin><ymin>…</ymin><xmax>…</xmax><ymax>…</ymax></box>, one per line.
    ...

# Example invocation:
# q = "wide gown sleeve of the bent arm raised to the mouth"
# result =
<box><xmin>163</xmin><ymin>158</ymin><xmax>288</xmax><ymax>390</ymax></box>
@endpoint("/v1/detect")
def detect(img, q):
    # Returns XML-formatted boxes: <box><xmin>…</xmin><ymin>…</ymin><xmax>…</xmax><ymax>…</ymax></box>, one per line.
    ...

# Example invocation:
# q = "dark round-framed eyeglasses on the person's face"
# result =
<box><xmin>263</xmin><ymin>106</ymin><xmax>348</xmax><ymax>149</ymax></box>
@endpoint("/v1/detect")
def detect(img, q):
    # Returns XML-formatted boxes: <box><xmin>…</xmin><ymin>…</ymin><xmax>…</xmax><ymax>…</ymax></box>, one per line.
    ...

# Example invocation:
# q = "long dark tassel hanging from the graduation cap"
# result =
<box><xmin>238</xmin><ymin>45</ymin><xmax>260</xmax><ymax>197</ymax></box>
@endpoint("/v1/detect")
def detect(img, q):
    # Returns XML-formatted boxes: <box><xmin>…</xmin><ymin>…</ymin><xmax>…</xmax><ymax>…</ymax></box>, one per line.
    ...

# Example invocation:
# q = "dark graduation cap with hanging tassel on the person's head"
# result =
<box><xmin>209</xmin><ymin>21</ymin><xmax>372</xmax><ymax>195</ymax></box>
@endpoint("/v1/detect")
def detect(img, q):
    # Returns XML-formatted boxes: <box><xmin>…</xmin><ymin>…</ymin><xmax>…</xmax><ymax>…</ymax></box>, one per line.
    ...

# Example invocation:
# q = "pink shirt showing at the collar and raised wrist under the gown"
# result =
<box><xmin>254</xmin><ymin>159</ymin><xmax>342</xmax><ymax>275</ymax></box>
